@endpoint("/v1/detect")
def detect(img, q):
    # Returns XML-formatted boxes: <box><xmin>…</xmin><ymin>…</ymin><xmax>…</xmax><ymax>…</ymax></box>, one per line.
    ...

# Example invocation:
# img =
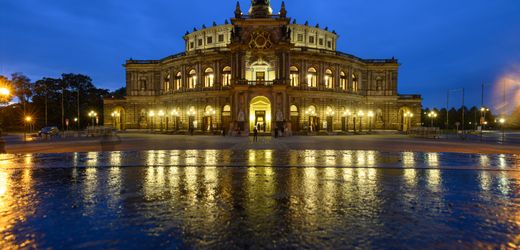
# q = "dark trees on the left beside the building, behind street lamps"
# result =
<box><xmin>0</xmin><ymin>73</ymin><xmax>124</xmax><ymax>130</ymax></box>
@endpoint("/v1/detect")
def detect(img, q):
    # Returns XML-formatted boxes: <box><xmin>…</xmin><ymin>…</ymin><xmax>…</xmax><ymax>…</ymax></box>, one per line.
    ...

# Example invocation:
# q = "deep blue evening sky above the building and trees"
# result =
<box><xmin>0</xmin><ymin>0</ymin><xmax>520</xmax><ymax>107</ymax></box>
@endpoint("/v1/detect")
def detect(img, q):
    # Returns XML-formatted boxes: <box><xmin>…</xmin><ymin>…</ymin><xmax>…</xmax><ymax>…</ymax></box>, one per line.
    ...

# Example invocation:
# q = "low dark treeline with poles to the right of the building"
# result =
<box><xmin>421</xmin><ymin>107</ymin><xmax>520</xmax><ymax>130</ymax></box>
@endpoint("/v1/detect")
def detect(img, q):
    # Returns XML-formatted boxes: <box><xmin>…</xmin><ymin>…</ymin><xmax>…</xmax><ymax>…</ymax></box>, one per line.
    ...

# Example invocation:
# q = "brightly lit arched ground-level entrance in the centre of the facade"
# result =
<box><xmin>249</xmin><ymin>96</ymin><xmax>271</xmax><ymax>133</ymax></box>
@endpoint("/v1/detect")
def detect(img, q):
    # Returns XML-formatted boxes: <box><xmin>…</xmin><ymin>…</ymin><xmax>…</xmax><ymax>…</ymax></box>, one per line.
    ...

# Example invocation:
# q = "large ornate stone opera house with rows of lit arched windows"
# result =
<box><xmin>104</xmin><ymin>0</ymin><xmax>422</xmax><ymax>134</ymax></box>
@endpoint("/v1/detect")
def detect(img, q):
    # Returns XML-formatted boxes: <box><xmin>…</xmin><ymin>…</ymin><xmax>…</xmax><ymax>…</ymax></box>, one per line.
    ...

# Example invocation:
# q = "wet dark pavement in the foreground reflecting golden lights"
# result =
<box><xmin>0</xmin><ymin>149</ymin><xmax>520</xmax><ymax>249</ymax></box>
